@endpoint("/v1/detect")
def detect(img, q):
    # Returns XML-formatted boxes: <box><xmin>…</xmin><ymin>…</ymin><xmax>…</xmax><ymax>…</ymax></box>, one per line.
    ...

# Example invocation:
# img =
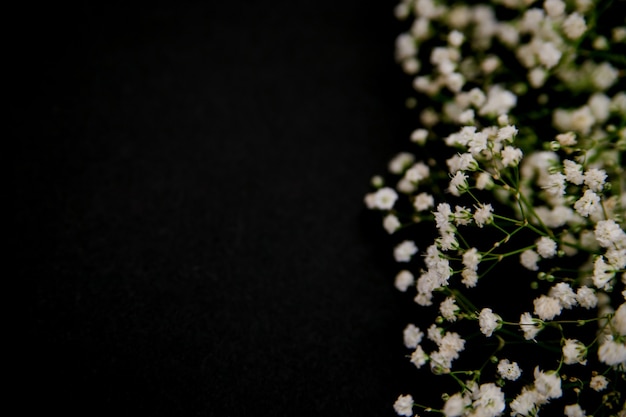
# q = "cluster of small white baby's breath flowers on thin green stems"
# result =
<box><xmin>365</xmin><ymin>0</ymin><xmax>626</xmax><ymax>417</ymax></box>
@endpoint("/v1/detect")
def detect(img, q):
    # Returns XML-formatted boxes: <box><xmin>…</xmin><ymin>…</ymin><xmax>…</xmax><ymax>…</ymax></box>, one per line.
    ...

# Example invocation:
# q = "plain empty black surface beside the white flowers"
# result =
<box><xmin>15</xmin><ymin>0</ymin><xmax>424</xmax><ymax>416</ymax></box>
